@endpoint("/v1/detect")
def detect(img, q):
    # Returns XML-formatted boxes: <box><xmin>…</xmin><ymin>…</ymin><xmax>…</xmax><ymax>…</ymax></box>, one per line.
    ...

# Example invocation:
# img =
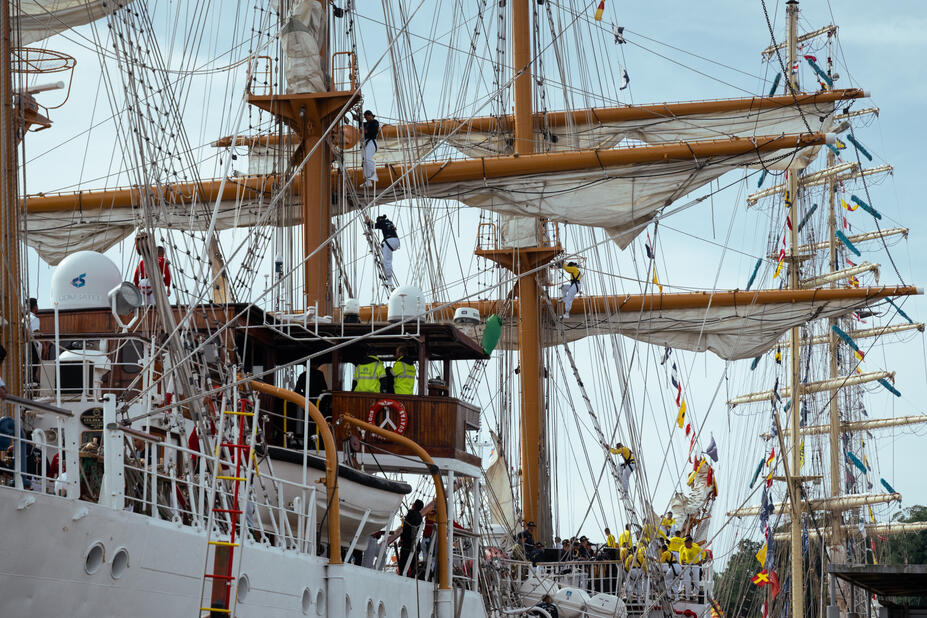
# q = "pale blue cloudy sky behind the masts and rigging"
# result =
<box><xmin>20</xmin><ymin>0</ymin><xmax>927</xmax><ymax>560</ymax></box>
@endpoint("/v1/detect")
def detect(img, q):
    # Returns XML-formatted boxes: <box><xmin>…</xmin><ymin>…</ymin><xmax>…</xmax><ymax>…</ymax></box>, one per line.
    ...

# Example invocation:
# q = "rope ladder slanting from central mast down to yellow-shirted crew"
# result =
<box><xmin>545</xmin><ymin>298</ymin><xmax>674</xmax><ymax>618</ymax></box>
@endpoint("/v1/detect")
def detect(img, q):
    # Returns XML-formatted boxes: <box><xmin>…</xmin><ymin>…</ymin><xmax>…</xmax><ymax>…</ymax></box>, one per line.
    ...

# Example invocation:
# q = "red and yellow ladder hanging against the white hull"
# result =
<box><xmin>200</xmin><ymin>397</ymin><xmax>257</xmax><ymax>616</ymax></box>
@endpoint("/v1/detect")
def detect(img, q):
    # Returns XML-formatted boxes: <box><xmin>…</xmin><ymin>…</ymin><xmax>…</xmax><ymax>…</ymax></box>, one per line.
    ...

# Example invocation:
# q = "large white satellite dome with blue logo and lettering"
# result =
<box><xmin>51</xmin><ymin>251</ymin><xmax>122</xmax><ymax>309</ymax></box>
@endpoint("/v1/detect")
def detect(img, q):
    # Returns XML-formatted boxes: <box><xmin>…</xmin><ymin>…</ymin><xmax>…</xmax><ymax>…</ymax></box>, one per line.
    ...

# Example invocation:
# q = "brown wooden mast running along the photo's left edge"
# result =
<box><xmin>0</xmin><ymin>0</ymin><xmax>25</xmax><ymax>395</ymax></box>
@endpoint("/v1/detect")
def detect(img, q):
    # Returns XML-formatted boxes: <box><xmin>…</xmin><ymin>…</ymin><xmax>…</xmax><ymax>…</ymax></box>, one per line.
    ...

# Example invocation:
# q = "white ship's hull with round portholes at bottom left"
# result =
<box><xmin>0</xmin><ymin>487</ymin><xmax>485</xmax><ymax>618</ymax></box>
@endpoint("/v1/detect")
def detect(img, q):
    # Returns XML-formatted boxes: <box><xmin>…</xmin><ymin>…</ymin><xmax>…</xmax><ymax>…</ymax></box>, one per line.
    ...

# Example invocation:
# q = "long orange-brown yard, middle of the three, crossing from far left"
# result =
<box><xmin>25</xmin><ymin>133</ymin><xmax>825</xmax><ymax>214</ymax></box>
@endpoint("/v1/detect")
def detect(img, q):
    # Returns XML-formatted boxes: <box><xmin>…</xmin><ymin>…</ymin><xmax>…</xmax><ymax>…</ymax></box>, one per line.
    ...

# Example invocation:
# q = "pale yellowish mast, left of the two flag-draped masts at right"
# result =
<box><xmin>783</xmin><ymin>0</ymin><xmax>805</xmax><ymax>618</ymax></box>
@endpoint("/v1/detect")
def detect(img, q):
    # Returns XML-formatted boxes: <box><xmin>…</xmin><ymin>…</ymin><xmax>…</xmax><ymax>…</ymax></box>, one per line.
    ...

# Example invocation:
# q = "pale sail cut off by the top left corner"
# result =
<box><xmin>12</xmin><ymin>0</ymin><xmax>126</xmax><ymax>45</ymax></box>
